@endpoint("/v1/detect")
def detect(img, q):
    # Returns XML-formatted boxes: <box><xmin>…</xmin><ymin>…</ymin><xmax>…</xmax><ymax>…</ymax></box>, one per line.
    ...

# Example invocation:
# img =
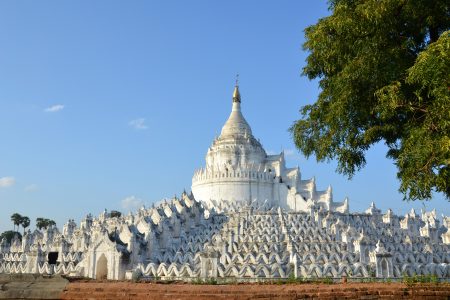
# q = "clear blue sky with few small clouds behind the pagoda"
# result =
<box><xmin>0</xmin><ymin>0</ymin><xmax>450</xmax><ymax>231</ymax></box>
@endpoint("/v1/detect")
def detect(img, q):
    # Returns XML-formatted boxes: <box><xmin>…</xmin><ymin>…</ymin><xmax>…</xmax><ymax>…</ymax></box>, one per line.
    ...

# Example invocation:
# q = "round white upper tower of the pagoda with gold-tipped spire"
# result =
<box><xmin>192</xmin><ymin>85</ymin><xmax>348</xmax><ymax>213</ymax></box>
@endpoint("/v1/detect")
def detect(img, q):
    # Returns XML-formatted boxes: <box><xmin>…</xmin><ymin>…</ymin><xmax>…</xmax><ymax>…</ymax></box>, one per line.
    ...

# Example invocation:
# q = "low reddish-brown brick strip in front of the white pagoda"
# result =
<box><xmin>61</xmin><ymin>281</ymin><xmax>450</xmax><ymax>300</ymax></box>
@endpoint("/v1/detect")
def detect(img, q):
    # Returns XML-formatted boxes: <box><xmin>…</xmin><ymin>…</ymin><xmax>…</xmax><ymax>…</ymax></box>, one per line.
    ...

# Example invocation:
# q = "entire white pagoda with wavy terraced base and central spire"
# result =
<box><xmin>0</xmin><ymin>86</ymin><xmax>450</xmax><ymax>281</ymax></box>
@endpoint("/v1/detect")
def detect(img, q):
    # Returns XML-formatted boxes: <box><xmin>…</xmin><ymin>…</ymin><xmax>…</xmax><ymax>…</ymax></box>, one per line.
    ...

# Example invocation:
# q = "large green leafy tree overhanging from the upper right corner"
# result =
<box><xmin>290</xmin><ymin>0</ymin><xmax>450</xmax><ymax>200</ymax></box>
